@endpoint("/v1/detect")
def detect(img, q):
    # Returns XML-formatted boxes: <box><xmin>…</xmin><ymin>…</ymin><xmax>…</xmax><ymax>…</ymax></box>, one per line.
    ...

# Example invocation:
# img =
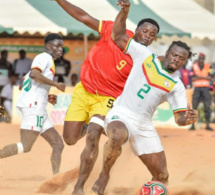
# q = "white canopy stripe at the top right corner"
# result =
<box><xmin>143</xmin><ymin>0</ymin><xmax>215</xmax><ymax>39</ymax></box>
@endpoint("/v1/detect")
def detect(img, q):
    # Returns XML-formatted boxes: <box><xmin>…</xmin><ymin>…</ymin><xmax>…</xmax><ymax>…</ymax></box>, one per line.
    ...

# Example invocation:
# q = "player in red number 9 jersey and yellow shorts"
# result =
<box><xmin>52</xmin><ymin>0</ymin><xmax>159</xmax><ymax>195</ymax></box>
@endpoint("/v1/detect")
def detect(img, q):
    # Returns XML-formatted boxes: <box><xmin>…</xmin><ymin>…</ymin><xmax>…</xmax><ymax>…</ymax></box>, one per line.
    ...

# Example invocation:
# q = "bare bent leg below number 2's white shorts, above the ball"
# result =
<box><xmin>139</xmin><ymin>151</ymin><xmax>169</xmax><ymax>184</ymax></box>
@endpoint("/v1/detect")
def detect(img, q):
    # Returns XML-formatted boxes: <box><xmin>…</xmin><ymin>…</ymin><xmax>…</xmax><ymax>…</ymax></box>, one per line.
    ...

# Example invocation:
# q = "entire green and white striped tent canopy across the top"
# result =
<box><xmin>0</xmin><ymin>0</ymin><xmax>215</xmax><ymax>40</ymax></box>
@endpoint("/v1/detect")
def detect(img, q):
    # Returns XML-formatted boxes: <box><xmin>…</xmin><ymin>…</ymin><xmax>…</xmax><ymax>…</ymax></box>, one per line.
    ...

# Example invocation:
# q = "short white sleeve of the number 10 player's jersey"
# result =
<box><xmin>31</xmin><ymin>54</ymin><xmax>49</xmax><ymax>72</ymax></box>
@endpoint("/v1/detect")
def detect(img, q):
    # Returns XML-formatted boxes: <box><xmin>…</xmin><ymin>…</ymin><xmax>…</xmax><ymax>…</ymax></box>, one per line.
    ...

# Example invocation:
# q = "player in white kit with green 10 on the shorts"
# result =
<box><xmin>0</xmin><ymin>33</ymin><xmax>65</xmax><ymax>174</ymax></box>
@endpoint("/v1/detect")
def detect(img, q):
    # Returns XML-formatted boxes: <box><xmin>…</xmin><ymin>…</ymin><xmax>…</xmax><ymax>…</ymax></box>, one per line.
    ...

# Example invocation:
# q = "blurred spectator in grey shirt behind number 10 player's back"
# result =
<box><xmin>14</xmin><ymin>49</ymin><xmax>32</xmax><ymax>84</ymax></box>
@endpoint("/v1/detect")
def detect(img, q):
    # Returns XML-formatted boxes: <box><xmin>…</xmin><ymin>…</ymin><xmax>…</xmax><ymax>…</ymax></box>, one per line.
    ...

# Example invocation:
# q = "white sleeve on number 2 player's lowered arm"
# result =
<box><xmin>167</xmin><ymin>81</ymin><xmax>187</xmax><ymax>113</ymax></box>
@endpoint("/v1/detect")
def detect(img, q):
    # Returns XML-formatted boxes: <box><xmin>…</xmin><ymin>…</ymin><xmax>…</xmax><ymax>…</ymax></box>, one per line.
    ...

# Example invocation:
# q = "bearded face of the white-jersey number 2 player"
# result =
<box><xmin>163</xmin><ymin>45</ymin><xmax>189</xmax><ymax>72</ymax></box>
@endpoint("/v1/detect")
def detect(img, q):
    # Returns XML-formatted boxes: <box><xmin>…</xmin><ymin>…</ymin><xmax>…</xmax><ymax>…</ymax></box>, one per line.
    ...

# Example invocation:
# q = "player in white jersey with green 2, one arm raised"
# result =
<box><xmin>92</xmin><ymin>0</ymin><xmax>198</xmax><ymax>195</ymax></box>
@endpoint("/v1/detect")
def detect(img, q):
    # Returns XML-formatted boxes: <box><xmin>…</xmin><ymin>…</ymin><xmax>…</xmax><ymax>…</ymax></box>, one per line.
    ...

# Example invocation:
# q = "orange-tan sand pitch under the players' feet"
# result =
<box><xmin>0</xmin><ymin>123</ymin><xmax>215</xmax><ymax>195</ymax></box>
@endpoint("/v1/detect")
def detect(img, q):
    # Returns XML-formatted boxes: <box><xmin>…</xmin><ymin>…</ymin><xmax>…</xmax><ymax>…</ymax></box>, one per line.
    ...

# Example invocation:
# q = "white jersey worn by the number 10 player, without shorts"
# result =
<box><xmin>17</xmin><ymin>52</ymin><xmax>55</xmax><ymax>114</ymax></box>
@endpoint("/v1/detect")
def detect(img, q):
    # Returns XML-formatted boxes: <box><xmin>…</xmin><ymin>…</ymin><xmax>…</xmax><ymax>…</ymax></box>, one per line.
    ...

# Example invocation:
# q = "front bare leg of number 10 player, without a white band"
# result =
<box><xmin>41</xmin><ymin>128</ymin><xmax>64</xmax><ymax>174</ymax></box>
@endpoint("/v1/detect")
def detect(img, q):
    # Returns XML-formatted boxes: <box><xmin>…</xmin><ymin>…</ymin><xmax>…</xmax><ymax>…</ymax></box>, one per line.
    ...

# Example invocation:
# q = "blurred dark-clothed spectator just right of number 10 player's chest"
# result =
<box><xmin>54</xmin><ymin>49</ymin><xmax>71</xmax><ymax>83</ymax></box>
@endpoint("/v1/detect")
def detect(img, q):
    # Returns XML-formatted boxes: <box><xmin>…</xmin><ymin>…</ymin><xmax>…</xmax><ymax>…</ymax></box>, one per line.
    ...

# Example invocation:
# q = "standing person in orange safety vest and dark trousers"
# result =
<box><xmin>190</xmin><ymin>53</ymin><xmax>213</xmax><ymax>131</ymax></box>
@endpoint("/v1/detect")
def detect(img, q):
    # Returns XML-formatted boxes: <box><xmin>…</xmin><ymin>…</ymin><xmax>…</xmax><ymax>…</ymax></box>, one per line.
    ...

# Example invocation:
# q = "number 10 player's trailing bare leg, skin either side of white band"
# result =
<box><xmin>0</xmin><ymin>129</ymin><xmax>39</xmax><ymax>158</ymax></box>
